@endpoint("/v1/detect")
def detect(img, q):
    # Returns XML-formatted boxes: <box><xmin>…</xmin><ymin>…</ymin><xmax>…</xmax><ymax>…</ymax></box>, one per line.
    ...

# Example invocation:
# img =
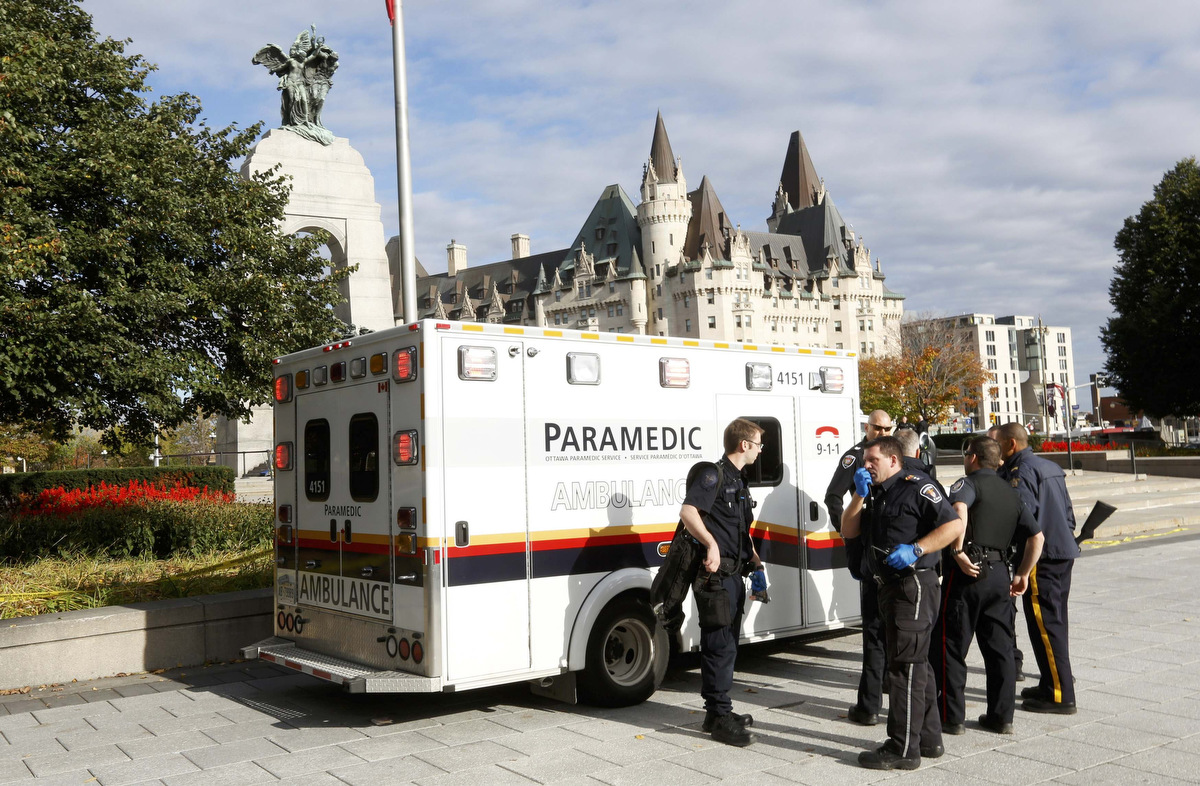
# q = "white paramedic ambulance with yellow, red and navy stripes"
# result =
<box><xmin>244</xmin><ymin>320</ymin><xmax>859</xmax><ymax>704</ymax></box>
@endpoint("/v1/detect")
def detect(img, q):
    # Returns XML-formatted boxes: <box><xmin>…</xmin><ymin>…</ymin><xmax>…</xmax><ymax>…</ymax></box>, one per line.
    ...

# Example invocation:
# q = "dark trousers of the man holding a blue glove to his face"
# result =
<box><xmin>880</xmin><ymin>569</ymin><xmax>942</xmax><ymax>757</ymax></box>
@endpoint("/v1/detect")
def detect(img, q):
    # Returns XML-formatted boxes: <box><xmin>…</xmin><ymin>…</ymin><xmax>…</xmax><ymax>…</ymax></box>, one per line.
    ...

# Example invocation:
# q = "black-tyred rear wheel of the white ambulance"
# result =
<box><xmin>578</xmin><ymin>596</ymin><xmax>671</xmax><ymax>707</ymax></box>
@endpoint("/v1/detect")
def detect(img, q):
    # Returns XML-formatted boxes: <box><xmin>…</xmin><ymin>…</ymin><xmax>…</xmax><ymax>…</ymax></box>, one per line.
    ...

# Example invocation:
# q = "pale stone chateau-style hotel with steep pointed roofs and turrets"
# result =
<box><xmin>398</xmin><ymin>114</ymin><xmax>904</xmax><ymax>355</ymax></box>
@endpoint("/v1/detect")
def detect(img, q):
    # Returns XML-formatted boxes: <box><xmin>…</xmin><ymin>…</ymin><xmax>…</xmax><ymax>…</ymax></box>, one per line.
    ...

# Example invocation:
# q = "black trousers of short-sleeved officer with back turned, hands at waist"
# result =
<box><xmin>929</xmin><ymin>559</ymin><xmax>1016</xmax><ymax>724</ymax></box>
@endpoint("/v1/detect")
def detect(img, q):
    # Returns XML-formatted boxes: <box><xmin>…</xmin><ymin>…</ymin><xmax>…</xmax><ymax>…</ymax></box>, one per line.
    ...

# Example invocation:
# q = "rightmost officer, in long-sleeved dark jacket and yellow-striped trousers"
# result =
<box><xmin>997</xmin><ymin>424</ymin><xmax>1079</xmax><ymax>715</ymax></box>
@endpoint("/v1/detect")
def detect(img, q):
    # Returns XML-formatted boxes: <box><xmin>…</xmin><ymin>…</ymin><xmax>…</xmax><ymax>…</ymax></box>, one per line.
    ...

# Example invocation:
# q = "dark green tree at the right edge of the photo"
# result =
<box><xmin>1100</xmin><ymin>157</ymin><xmax>1200</xmax><ymax>418</ymax></box>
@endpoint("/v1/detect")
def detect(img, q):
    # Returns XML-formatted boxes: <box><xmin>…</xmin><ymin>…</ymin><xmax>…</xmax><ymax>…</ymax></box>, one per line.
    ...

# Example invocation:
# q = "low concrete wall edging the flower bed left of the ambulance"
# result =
<box><xmin>0</xmin><ymin>589</ymin><xmax>274</xmax><ymax>689</ymax></box>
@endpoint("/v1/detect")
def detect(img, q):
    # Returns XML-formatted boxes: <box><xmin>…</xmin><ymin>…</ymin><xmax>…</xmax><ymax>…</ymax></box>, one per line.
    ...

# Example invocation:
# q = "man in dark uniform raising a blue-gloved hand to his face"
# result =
<box><xmin>841</xmin><ymin>437</ymin><xmax>964</xmax><ymax>769</ymax></box>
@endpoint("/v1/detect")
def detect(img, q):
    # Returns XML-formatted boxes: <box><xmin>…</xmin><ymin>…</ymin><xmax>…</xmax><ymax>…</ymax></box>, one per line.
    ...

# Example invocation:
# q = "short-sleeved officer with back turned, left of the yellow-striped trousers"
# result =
<box><xmin>929</xmin><ymin>437</ymin><xmax>1043</xmax><ymax>734</ymax></box>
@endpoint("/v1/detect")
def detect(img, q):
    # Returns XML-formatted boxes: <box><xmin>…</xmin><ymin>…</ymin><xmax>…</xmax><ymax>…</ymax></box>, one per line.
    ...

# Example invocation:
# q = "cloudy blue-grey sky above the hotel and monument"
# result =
<box><xmin>84</xmin><ymin>0</ymin><xmax>1200</xmax><ymax>393</ymax></box>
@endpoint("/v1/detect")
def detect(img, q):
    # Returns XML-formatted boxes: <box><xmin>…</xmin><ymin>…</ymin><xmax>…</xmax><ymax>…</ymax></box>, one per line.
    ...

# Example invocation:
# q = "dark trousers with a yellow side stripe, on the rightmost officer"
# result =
<box><xmin>1024</xmin><ymin>559</ymin><xmax>1075</xmax><ymax>703</ymax></box>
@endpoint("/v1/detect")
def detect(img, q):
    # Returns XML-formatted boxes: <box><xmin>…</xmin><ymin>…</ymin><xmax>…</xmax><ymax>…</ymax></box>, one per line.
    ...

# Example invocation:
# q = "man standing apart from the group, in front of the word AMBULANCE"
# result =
<box><xmin>679</xmin><ymin>418</ymin><xmax>763</xmax><ymax>746</ymax></box>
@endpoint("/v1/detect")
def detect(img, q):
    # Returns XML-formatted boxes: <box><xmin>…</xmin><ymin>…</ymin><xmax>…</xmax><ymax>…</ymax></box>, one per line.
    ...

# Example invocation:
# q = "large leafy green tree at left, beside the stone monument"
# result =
<box><xmin>0</xmin><ymin>0</ymin><xmax>348</xmax><ymax>449</ymax></box>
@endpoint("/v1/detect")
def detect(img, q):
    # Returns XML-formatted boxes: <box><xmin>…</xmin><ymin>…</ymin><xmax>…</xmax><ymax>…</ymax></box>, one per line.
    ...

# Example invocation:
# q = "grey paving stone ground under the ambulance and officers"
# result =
<box><xmin>0</xmin><ymin>534</ymin><xmax>1200</xmax><ymax>786</ymax></box>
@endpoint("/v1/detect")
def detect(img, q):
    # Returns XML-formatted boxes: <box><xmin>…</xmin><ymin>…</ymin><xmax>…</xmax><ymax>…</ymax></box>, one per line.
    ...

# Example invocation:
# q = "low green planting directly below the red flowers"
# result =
<box><xmin>0</xmin><ymin>500</ymin><xmax>274</xmax><ymax>562</ymax></box>
